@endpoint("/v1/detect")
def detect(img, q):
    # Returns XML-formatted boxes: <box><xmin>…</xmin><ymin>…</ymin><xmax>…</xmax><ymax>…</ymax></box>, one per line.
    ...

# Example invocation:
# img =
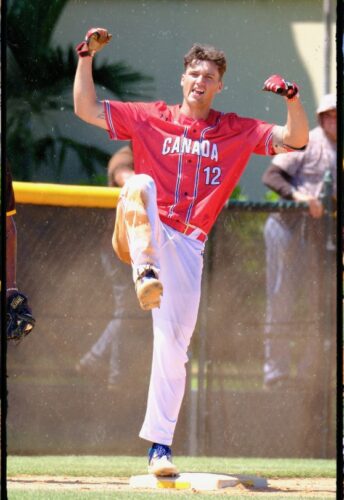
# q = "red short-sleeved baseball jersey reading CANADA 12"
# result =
<box><xmin>104</xmin><ymin>100</ymin><xmax>274</xmax><ymax>233</ymax></box>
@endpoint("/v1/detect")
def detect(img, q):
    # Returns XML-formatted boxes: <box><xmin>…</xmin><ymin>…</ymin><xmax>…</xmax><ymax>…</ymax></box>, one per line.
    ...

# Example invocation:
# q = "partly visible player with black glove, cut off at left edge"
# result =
<box><xmin>6</xmin><ymin>162</ymin><xmax>35</xmax><ymax>342</ymax></box>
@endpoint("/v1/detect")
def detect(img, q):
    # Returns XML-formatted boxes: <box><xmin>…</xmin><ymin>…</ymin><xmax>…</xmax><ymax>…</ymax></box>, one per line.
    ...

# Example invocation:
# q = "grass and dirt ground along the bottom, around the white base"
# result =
<box><xmin>7</xmin><ymin>456</ymin><xmax>336</xmax><ymax>500</ymax></box>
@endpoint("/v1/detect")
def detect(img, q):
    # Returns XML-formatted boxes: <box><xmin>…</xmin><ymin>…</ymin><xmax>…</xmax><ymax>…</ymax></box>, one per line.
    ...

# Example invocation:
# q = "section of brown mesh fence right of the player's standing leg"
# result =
<box><xmin>197</xmin><ymin>199</ymin><xmax>336</xmax><ymax>457</ymax></box>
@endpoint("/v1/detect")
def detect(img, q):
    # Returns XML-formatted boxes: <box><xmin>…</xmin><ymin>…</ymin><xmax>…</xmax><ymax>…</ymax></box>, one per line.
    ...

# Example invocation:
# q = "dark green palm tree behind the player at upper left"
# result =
<box><xmin>6</xmin><ymin>0</ymin><xmax>152</xmax><ymax>182</ymax></box>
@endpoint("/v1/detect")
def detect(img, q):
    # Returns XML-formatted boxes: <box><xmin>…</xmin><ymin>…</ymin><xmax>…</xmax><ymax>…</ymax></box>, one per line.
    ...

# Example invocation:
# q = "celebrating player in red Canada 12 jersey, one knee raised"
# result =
<box><xmin>74</xmin><ymin>28</ymin><xmax>308</xmax><ymax>475</ymax></box>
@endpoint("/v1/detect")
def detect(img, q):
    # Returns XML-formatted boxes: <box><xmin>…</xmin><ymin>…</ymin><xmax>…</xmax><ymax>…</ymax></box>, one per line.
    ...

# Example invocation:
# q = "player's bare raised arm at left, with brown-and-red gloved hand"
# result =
<box><xmin>73</xmin><ymin>28</ymin><xmax>112</xmax><ymax>129</ymax></box>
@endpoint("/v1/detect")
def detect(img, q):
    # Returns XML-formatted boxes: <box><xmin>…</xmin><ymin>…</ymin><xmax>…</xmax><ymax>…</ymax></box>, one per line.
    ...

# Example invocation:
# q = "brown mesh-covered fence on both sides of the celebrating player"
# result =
<box><xmin>7</xmin><ymin>194</ymin><xmax>336</xmax><ymax>458</ymax></box>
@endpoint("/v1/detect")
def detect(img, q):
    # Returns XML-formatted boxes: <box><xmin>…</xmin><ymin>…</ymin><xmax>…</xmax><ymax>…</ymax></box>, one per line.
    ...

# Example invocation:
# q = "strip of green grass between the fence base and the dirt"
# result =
<box><xmin>7</xmin><ymin>455</ymin><xmax>336</xmax><ymax>479</ymax></box>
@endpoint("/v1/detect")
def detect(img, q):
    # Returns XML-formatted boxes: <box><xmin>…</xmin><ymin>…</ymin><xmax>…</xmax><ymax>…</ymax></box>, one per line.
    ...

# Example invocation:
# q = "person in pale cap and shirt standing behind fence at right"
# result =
<box><xmin>263</xmin><ymin>94</ymin><xmax>337</xmax><ymax>389</ymax></box>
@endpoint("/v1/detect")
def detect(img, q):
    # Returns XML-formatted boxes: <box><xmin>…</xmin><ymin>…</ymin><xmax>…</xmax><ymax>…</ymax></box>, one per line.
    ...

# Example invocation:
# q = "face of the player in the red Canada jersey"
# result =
<box><xmin>181</xmin><ymin>61</ymin><xmax>222</xmax><ymax>107</ymax></box>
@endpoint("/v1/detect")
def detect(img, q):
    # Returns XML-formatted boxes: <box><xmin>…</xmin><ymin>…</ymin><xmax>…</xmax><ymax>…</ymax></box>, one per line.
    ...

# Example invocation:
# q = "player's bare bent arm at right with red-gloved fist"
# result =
<box><xmin>263</xmin><ymin>75</ymin><xmax>309</xmax><ymax>153</ymax></box>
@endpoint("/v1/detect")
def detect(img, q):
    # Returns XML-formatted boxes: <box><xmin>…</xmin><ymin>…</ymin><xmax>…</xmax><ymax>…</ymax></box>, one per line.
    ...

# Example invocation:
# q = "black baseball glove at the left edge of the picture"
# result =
<box><xmin>6</xmin><ymin>292</ymin><xmax>36</xmax><ymax>342</ymax></box>
